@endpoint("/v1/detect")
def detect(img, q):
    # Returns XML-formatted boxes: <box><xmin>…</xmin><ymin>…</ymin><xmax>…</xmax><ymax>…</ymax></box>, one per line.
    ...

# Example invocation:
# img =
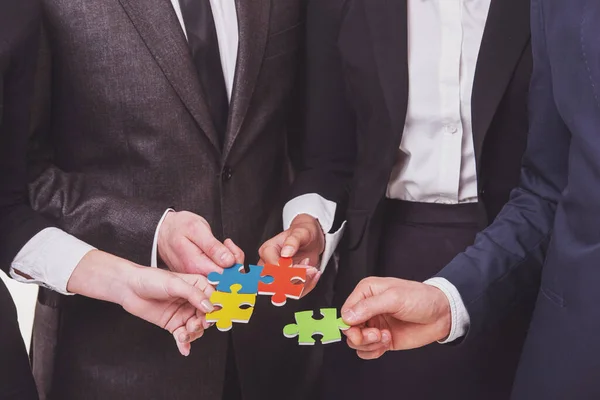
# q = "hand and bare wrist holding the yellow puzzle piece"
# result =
<box><xmin>67</xmin><ymin>250</ymin><xmax>214</xmax><ymax>356</ymax></box>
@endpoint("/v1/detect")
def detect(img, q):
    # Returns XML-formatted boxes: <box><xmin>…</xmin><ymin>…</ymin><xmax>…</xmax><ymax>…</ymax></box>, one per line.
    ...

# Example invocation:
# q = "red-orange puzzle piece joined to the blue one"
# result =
<box><xmin>258</xmin><ymin>258</ymin><xmax>306</xmax><ymax>307</ymax></box>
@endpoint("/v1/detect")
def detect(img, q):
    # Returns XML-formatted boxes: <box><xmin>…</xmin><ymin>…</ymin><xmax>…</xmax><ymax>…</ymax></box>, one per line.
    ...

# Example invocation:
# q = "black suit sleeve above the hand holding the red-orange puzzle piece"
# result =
<box><xmin>292</xmin><ymin>0</ymin><xmax>356</xmax><ymax>231</ymax></box>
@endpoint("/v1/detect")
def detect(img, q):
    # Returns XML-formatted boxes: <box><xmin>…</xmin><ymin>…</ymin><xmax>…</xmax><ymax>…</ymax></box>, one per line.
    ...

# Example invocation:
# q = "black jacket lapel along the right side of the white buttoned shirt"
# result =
<box><xmin>471</xmin><ymin>0</ymin><xmax>530</xmax><ymax>160</ymax></box>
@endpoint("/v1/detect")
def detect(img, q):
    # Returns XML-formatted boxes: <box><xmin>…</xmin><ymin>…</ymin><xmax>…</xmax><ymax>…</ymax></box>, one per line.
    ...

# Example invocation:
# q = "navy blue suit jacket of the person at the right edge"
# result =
<box><xmin>440</xmin><ymin>0</ymin><xmax>600</xmax><ymax>400</ymax></box>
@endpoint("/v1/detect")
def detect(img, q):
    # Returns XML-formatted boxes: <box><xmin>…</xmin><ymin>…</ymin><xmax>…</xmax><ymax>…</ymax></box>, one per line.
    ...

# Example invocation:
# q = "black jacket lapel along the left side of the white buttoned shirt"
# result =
<box><xmin>363</xmin><ymin>0</ymin><xmax>408</xmax><ymax>141</ymax></box>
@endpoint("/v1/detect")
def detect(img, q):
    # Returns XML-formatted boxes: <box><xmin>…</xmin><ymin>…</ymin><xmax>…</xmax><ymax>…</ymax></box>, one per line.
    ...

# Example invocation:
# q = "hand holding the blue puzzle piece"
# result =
<box><xmin>158</xmin><ymin>211</ymin><xmax>244</xmax><ymax>276</ymax></box>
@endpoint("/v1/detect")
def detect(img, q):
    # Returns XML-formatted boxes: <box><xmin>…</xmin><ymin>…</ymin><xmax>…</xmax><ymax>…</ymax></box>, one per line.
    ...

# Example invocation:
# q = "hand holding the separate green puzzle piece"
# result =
<box><xmin>342</xmin><ymin>278</ymin><xmax>452</xmax><ymax>360</ymax></box>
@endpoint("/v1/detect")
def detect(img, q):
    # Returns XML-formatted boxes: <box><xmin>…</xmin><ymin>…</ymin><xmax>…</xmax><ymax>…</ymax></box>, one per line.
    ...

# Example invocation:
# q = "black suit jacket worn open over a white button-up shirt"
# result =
<box><xmin>293</xmin><ymin>0</ymin><xmax>532</xmax><ymax>299</ymax></box>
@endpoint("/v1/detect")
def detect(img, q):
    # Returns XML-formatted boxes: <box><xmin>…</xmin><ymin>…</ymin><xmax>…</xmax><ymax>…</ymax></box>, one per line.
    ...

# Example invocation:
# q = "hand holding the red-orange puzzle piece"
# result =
<box><xmin>258</xmin><ymin>214</ymin><xmax>325</xmax><ymax>296</ymax></box>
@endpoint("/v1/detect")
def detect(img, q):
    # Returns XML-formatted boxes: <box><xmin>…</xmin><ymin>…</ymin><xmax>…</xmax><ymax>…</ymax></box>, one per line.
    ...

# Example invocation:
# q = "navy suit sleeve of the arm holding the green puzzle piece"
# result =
<box><xmin>439</xmin><ymin>0</ymin><xmax>571</xmax><ymax>336</ymax></box>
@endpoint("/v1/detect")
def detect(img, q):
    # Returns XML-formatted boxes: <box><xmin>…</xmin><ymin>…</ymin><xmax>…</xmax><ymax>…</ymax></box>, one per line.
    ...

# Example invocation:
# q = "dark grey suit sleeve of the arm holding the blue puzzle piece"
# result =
<box><xmin>28</xmin><ymin>29</ymin><xmax>168</xmax><ymax>265</ymax></box>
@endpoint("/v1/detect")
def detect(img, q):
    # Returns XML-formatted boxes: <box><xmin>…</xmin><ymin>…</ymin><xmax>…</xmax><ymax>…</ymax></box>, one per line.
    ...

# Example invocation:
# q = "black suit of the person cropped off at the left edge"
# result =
<box><xmin>0</xmin><ymin>0</ymin><xmax>45</xmax><ymax>400</ymax></box>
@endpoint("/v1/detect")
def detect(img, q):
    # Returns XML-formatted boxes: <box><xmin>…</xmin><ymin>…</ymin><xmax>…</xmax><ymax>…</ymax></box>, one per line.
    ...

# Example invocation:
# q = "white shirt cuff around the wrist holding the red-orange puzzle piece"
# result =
<box><xmin>283</xmin><ymin>193</ymin><xmax>346</xmax><ymax>272</ymax></box>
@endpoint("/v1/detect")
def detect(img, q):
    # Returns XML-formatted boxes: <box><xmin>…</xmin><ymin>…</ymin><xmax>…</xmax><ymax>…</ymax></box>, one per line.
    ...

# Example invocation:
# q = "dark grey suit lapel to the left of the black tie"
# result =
<box><xmin>119</xmin><ymin>0</ymin><xmax>221</xmax><ymax>152</ymax></box>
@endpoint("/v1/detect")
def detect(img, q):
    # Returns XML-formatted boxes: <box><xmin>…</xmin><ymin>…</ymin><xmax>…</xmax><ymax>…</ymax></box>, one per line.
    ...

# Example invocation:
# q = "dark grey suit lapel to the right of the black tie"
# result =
<box><xmin>223</xmin><ymin>0</ymin><xmax>271</xmax><ymax>159</ymax></box>
